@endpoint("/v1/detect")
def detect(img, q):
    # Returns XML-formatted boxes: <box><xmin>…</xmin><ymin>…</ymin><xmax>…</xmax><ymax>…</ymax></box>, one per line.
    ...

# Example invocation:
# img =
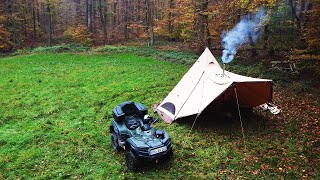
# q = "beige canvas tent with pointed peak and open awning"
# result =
<box><xmin>155</xmin><ymin>48</ymin><xmax>272</xmax><ymax>124</ymax></box>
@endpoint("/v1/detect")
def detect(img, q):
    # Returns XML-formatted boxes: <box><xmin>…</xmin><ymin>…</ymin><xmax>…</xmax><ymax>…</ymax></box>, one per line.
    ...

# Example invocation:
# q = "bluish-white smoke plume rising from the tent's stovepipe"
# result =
<box><xmin>221</xmin><ymin>8</ymin><xmax>267</xmax><ymax>64</ymax></box>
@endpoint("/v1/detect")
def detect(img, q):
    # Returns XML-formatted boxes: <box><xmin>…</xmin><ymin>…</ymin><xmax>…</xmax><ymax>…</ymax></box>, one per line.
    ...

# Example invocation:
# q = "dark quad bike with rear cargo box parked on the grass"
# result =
<box><xmin>110</xmin><ymin>101</ymin><xmax>173</xmax><ymax>171</ymax></box>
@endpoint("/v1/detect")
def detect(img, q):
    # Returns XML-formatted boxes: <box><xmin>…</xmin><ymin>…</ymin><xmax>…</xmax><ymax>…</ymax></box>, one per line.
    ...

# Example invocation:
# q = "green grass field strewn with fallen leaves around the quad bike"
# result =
<box><xmin>0</xmin><ymin>53</ymin><xmax>320</xmax><ymax>179</ymax></box>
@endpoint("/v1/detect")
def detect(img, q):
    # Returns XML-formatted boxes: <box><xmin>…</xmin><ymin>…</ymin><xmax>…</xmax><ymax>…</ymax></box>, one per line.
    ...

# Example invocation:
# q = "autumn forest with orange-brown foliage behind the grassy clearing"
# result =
<box><xmin>0</xmin><ymin>0</ymin><xmax>320</xmax><ymax>56</ymax></box>
